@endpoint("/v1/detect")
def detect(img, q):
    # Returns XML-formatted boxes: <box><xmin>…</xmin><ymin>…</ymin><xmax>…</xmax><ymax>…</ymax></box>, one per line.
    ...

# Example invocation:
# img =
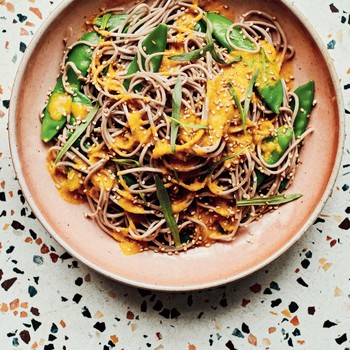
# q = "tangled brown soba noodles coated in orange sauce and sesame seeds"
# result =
<box><xmin>48</xmin><ymin>0</ymin><xmax>311</xmax><ymax>254</ymax></box>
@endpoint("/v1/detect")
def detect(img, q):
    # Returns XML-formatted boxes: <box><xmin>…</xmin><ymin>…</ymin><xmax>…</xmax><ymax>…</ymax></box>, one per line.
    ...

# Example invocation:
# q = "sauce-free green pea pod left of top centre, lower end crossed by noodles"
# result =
<box><xmin>123</xmin><ymin>23</ymin><xmax>168</xmax><ymax>91</ymax></box>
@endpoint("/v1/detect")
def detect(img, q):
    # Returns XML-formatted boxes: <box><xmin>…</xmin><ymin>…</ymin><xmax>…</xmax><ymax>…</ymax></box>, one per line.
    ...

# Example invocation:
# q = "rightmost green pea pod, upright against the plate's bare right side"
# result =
<box><xmin>291</xmin><ymin>80</ymin><xmax>315</xmax><ymax>139</ymax></box>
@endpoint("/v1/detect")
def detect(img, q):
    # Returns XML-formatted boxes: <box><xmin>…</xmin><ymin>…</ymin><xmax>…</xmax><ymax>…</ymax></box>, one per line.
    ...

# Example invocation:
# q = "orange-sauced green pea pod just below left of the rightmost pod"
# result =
<box><xmin>263</xmin><ymin>126</ymin><xmax>293</xmax><ymax>165</ymax></box>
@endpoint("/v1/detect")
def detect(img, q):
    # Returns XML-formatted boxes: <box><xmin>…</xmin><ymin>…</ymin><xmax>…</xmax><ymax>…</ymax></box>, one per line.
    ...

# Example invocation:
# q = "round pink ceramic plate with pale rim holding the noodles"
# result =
<box><xmin>9</xmin><ymin>0</ymin><xmax>344</xmax><ymax>291</ymax></box>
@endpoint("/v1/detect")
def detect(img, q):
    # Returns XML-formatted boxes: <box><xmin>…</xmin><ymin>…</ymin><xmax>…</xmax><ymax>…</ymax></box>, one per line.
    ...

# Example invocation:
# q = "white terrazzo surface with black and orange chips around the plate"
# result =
<box><xmin>0</xmin><ymin>0</ymin><xmax>350</xmax><ymax>350</ymax></box>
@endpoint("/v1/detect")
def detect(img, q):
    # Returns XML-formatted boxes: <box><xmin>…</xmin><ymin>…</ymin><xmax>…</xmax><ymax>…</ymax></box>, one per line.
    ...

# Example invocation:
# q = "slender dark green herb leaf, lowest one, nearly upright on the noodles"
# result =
<box><xmin>154</xmin><ymin>175</ymin><xmax>181</xmax><ymax>246</ymax></box>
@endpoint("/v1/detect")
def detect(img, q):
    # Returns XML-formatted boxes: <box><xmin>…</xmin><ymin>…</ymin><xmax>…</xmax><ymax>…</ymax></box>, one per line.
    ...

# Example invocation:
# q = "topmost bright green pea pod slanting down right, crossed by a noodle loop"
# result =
<box><xmin>207</xmin><ymin>12</ymin><xmax>256</xmax><ymax>51</ymax></box>
